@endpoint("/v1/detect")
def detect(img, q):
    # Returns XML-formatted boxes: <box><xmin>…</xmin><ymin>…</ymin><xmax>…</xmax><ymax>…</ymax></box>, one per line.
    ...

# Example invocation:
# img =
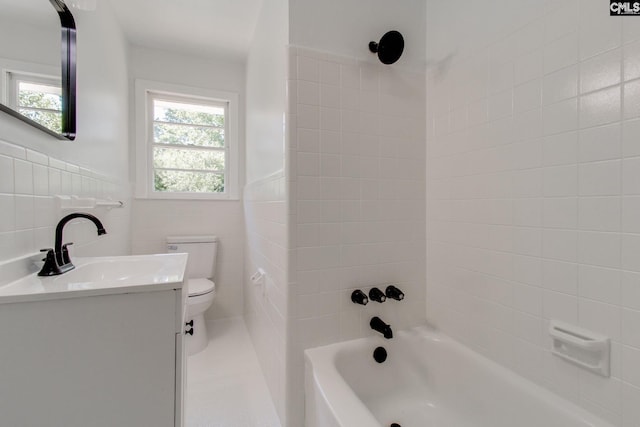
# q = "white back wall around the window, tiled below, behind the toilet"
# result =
<box><xmin>130</xmin><ymin>46</ymin><xmax>245</xmax><ymax>320</ymax></box>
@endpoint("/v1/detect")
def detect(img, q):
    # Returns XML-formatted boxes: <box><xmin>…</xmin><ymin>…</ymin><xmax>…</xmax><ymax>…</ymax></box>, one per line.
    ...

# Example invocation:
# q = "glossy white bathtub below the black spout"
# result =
<box><xmin>305</xmin><ymin>327</ymin><xmax>613</xmax><ymax>427</ymax></box>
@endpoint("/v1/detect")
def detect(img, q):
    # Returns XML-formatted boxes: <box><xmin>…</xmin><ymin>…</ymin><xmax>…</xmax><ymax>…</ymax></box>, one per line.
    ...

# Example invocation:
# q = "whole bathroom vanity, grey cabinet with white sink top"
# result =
<box><xmin>0</xmin><ymin>254</ymin><xmax>187</xmax><ymax>427</ymax></box>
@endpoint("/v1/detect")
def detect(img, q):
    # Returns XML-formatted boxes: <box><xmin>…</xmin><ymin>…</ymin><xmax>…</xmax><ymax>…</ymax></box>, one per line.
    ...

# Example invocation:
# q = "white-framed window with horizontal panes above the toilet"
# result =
<box><xmin>136</xmin><ymin>81</ymin><xmax>238</xmax><ymax>199</ymax></box>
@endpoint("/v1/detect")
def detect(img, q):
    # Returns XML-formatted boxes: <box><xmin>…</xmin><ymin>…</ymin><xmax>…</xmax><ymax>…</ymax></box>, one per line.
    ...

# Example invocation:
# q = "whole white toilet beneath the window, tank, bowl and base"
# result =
<box><xmin>167</xmin><ymin>236</ymin><xmax>218</xmax><ymax>356</ymax></box>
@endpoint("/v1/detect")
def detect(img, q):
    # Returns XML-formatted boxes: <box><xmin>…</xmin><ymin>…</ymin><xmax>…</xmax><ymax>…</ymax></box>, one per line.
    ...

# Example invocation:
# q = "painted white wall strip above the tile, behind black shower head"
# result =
<box><xmin>290</xmin><ymin>0</ymin><xmax>425</xmax><ymax>69</ymax></box>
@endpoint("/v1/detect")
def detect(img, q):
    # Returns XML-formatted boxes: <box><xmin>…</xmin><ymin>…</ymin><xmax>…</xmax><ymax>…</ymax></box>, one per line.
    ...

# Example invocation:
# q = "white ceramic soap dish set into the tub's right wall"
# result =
<box><xmin>549</xmin><ymin>320</ymin><xmax>611</xmax><ymax>377</ymax></box>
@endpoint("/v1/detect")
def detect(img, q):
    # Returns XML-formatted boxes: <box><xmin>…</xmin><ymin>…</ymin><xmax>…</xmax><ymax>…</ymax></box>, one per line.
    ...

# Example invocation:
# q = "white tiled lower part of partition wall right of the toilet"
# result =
<box><xmin>243</xmin><ymin>171</ymin><xmax>289</xmax><ymax>425</ymax></box>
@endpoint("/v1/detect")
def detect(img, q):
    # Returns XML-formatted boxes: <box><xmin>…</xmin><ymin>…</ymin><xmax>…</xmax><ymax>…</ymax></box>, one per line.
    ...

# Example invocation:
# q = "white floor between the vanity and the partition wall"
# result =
<box><xmin>185</xmin><ymin>318</ymin><xmax>281</xmax><ymax>427</ymax></box>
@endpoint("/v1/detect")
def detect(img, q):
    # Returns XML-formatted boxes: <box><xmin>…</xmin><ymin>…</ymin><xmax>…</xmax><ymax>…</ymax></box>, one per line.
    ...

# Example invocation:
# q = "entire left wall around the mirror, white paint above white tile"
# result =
<box><xmin>0</xmin><ymin>4</ymin><xmax>130</xmax><ymax>260</ymax></box>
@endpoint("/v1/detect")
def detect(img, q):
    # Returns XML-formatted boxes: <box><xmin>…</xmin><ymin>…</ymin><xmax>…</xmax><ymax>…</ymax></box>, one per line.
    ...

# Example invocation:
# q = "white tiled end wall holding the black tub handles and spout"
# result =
<box><xmin>287</xmin><ymin>47</ymin><xmax>426</xmax><ymax>425</ymax></box>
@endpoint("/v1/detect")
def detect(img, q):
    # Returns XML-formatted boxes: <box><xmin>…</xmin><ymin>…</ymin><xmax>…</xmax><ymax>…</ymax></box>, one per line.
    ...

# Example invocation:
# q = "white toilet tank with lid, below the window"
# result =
<box><xmin>167</xmin><ymin>236</ymin><xmax>218</xmax><ymax>279</ymax></box>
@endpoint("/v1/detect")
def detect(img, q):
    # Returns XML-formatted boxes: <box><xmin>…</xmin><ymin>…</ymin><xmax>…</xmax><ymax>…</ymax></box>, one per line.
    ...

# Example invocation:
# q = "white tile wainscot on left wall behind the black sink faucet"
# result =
<box><xmin>0</xmin><ymin>141</ymin><xmax>130</xmax><ymax>262</ymax></box>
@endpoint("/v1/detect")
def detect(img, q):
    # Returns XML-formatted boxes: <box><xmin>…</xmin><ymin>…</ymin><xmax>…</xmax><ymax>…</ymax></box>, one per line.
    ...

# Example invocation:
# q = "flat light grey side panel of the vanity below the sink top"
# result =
<box><xmin>0</xmin><ymin>291</ymin><xmax>176</xmax><ymax>427</ymax></box>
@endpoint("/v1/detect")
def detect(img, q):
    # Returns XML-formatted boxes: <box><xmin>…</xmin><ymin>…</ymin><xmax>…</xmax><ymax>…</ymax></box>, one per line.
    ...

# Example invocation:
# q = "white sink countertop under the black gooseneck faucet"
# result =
<box><xmin>0</xmin><ymin>254</ymin><xmax>187</xmax><ymax>304</ymax></box>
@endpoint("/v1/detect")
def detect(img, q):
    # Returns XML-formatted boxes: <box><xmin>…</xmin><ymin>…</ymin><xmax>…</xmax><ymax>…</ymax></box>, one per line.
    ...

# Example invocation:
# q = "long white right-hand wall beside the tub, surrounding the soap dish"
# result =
<box><xmin>427</xmin><ymin>0</ymin><xmax>640</xmax><ymax>426</ymax></box>
